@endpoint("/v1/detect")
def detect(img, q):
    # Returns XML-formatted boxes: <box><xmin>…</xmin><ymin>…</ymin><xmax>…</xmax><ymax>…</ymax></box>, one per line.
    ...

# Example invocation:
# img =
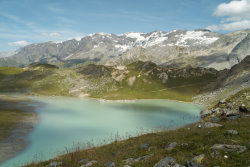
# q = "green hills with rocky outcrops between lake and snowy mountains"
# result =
<box><xmin>0</xmin><ymin>56</ymin><xmax>250</xmax><ymax>103</ymax></box>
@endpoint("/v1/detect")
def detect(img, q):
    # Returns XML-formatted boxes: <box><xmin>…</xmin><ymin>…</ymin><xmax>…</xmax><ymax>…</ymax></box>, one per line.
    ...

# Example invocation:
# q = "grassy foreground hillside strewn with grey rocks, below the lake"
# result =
<box><xmin>23</xmin><ymin>88</ymin><xmax>250</xmax><ymax>167</ymax></box>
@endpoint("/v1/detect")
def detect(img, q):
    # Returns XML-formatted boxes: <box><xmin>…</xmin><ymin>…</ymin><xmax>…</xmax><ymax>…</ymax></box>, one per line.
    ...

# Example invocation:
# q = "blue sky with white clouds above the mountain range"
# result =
<box><xmin>0</xmin><ymin>0</ymin><xmax>250</xmax><ymax>52</ymax></box>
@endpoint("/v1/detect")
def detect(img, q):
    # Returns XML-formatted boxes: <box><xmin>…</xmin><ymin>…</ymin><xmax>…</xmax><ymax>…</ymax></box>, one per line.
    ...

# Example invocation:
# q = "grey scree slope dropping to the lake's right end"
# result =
<box><xmin>193</xmin><ymin>56</ymin><xmax>250</xmax><ymax>106</ymax></box>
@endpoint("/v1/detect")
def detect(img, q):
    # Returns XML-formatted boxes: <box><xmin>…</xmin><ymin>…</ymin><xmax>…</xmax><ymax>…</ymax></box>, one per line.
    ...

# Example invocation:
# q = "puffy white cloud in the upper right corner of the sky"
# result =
<box><xmin>207</xmin><ymin>0</ymin><xmax>250</xmax><ymax>31</ymax></box>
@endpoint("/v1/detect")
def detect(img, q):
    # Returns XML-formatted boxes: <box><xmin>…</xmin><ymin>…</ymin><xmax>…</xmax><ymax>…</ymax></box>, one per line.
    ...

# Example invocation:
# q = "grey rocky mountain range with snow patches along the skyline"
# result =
<box><xmin>0</xmin><ymin>30</ymin><xmax>250</xmax><ymax>70</ymax></box>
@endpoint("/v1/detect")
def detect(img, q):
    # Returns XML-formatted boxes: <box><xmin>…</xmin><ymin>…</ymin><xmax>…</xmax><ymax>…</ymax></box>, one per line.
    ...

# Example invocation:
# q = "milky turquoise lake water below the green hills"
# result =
<box><xmin>0</xmin><ymin>97</ymin><xmax>202</xmax><ymax>167</ymax></box>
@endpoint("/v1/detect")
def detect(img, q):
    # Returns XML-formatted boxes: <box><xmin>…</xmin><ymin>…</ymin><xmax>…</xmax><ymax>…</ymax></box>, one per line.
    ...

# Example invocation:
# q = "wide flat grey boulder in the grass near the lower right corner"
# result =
<box><xmin>211</xmin><ymin>144</ymin><xmax>247</xmax><ymax>153</ymax></box>
